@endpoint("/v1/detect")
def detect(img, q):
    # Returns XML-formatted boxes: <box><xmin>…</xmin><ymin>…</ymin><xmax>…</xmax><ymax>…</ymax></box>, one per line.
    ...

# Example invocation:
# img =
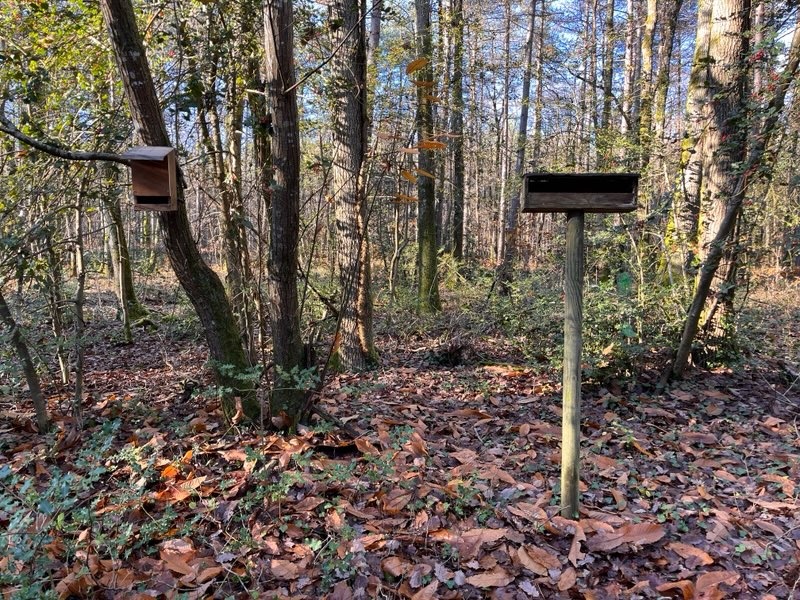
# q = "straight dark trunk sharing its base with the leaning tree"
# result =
<box><xmin>264</xmin><ymin>0</ymin><xmax>304</xmax><ymax>424</ymax></box>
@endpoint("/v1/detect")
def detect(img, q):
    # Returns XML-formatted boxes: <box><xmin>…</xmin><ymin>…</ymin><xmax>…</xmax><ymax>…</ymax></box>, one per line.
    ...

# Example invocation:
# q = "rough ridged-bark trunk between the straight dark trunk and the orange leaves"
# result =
<box><xmin>330</xmin><ymin>0</ymin><xmax>374</xmax><ymax>370</ymax></box>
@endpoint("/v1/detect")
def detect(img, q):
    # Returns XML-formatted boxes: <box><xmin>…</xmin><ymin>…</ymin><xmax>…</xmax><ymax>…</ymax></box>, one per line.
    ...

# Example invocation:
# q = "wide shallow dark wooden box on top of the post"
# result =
<box><xmin>522</xmin><ymin>173</ymin><xmax>639</xmax><ymax>213</ymax></box>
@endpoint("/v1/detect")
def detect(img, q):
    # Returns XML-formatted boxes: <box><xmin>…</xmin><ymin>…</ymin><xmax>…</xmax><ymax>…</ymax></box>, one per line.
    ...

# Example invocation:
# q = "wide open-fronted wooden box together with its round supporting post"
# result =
<box><xmin>522</xmin><ymin>173</ymin><xmax>639</xmax><ymax>519</ymax></box>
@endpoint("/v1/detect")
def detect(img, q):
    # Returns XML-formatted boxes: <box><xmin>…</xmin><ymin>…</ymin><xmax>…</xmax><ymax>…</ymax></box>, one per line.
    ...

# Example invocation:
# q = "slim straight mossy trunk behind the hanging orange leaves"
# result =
<box><xmin>414</xmin><ymin>0</ymin><xmax>442</xmax><ymax>312</ymax></box>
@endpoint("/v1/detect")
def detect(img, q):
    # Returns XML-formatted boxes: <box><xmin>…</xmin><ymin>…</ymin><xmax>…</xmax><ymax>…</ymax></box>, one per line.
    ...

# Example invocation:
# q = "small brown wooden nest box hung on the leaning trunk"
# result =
<box><xmin>122</xmin><ymin>146</ymin><xmax>178</xmax><ymax>211</ymax></box>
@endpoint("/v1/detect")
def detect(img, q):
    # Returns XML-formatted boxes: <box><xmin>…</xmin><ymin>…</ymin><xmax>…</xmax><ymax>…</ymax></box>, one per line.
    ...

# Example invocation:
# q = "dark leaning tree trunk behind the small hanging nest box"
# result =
<box><xmin>100</xmin><ymin>0</ymin><xmax>261</xmax><ymax>419</ymax></box>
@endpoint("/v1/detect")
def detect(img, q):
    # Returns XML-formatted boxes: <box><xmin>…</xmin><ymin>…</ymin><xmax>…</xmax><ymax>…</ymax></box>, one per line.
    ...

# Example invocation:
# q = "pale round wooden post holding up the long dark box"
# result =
<box><xmin>561</xmin><ymin>210</ymin><xmax>584</xmax><ymax>519</ymax></box>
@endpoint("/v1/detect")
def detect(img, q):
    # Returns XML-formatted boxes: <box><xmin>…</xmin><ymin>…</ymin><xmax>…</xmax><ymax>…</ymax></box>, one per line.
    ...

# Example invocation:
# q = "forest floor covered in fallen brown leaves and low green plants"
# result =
<box><xmin>0</xmin><ymin>274</ymin><xmax>800</xmax><ymax>600</ymax></box>
